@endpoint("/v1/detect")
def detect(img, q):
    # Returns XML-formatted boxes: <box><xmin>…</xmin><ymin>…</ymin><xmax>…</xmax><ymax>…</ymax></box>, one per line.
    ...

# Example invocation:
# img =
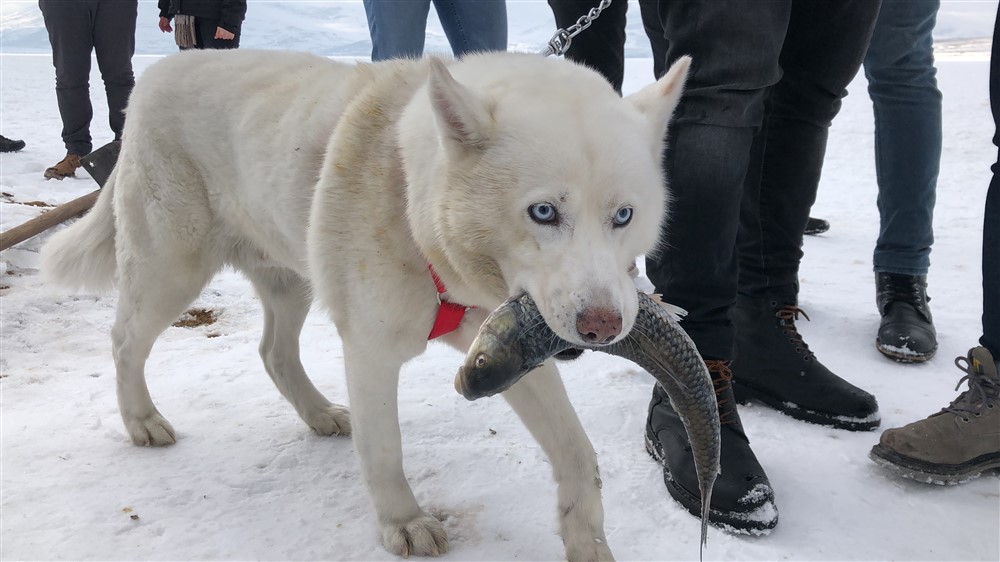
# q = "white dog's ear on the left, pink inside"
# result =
<box><xmin>428</xmin><ymin>58</ymin><xmax>492</xmax><ymax>147</ymax></box>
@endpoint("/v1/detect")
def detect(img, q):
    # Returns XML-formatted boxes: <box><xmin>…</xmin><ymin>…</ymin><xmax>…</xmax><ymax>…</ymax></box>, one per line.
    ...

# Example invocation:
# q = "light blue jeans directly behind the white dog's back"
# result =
<box><xmin>364</xmin><ymin>0</ymin><xmax>507</xmax><ymax>61</ymax></box>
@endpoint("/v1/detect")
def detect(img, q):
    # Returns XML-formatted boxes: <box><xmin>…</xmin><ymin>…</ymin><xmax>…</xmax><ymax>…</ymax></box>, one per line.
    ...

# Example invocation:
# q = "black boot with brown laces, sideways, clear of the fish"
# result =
<box><xmin>731</xmin><ymin>292</ymin><xmax>881</xmax><ymax>431</ymax></box>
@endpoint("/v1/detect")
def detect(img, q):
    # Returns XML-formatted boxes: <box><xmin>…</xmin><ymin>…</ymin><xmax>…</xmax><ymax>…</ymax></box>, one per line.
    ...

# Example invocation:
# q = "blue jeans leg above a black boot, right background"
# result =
<box><xmin>864</xmin><ymin>0</ymin><xmax>941</xmax><ymax>275</ymax></box>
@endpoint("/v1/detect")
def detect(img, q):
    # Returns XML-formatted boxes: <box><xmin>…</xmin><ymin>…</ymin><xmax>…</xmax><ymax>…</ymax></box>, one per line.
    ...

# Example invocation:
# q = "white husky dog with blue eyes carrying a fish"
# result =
<box><xmin>42</xmin><ymin>49</ymin><xmax>689</xmax><ymax>560</ymax></box>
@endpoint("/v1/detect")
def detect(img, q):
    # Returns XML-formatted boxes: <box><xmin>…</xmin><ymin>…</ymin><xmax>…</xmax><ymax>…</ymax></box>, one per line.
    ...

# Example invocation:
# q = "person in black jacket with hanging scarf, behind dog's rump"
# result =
<box><xmin>157</xmin><ymin>0</ymin><xmax>247</xmax><ymax>51</ymax></box>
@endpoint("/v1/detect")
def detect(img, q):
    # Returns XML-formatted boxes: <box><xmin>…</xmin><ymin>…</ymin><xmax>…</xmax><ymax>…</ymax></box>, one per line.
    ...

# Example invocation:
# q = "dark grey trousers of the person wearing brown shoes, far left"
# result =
<box><xmin>38</xmin><ymin>0</ymin><xmax>138</xmax><ymax>155</ymax></box>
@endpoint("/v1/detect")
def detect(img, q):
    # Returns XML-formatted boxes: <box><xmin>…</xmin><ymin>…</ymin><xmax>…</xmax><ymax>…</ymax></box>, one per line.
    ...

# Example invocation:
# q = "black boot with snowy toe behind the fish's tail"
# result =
<box><xmin>646</xmin><ymin>361</ymin><xmax>778</xmax><ymax>535</ymax></box>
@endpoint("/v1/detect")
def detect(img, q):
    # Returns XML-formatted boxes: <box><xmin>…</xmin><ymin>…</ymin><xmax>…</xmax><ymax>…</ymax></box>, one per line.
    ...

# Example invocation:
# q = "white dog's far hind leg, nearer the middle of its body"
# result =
<box><xmin>244</xmin><ymin>268</ymin><xmax>351</xmax><ymax>435</ymax></box>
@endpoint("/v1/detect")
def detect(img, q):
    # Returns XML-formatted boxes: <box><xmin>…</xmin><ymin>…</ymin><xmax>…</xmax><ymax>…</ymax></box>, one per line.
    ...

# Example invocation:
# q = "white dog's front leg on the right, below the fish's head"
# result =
<box><xmin>503</xmin><ymin>361</ymin><xmax>614</xmax><ymax>562</ymax></box>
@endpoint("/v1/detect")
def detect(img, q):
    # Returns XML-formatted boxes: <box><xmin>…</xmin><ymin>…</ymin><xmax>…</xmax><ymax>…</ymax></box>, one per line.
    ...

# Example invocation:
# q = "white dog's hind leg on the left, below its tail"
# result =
<box><xmin>111</xmin><ymin>254</ymin><xmax>214</xmax><ymax>445</ymax></box>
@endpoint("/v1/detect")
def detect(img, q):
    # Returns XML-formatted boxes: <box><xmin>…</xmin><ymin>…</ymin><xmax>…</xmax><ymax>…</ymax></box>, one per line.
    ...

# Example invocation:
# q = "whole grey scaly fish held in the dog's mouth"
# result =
<box><xmin>455</xmin><ymin>292</ymin><xmax>722</xmax><ymax>545</ymax></box>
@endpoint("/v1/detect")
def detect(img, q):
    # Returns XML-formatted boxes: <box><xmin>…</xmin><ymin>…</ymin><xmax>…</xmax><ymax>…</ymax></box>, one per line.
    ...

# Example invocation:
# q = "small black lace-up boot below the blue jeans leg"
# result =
<box><xmin>875</xmin><ymin>273</ymin><xmax>937</xmax><ymax>363</ymax></box>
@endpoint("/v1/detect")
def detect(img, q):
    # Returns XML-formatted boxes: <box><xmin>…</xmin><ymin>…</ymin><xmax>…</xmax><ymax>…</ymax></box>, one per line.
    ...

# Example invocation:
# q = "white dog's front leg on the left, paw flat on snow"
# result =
<box><xmin>344</xmin><ymin>337</ymin><xmax>448</xmax><ymax>557</ymax></box>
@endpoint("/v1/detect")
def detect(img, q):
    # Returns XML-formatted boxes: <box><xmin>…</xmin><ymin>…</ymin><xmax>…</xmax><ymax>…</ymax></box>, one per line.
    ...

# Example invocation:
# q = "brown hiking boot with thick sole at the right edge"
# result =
<box><xmin>868</xmin><ymin>347</ymin><xmax>1000</xmax><ymax>484</ymax></box>
